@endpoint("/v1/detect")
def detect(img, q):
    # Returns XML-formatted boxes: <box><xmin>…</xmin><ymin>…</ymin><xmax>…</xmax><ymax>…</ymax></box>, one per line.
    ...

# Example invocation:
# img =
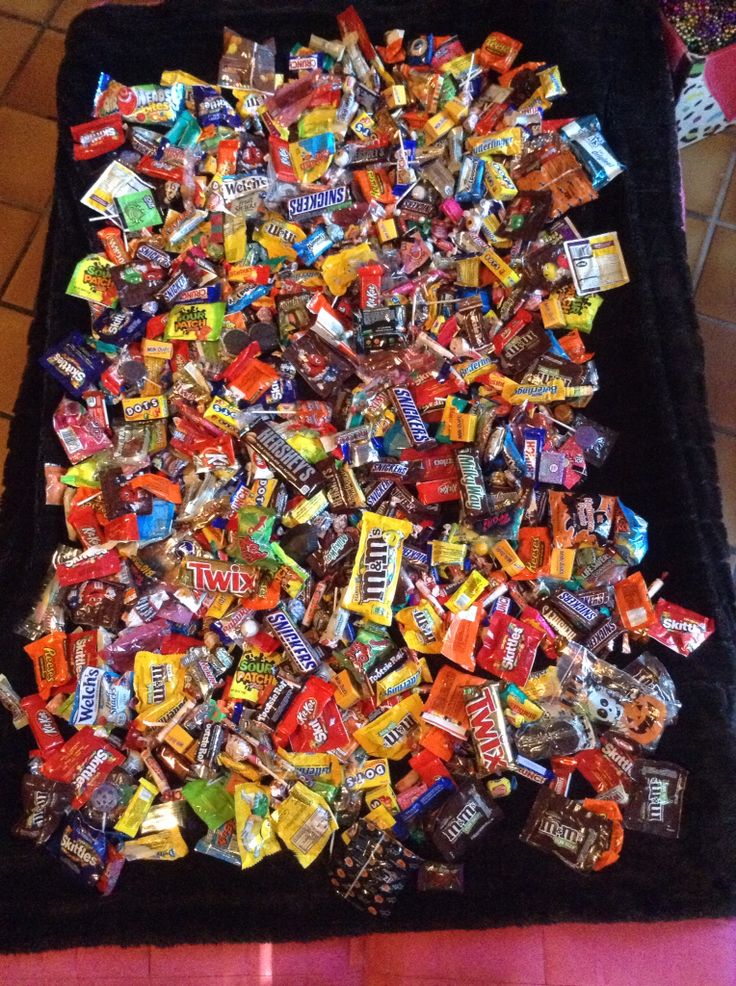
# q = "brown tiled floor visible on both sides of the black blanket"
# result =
<box><xmin>0</xmin><ymin>0</ymin><xmax>736</xmax><ymax>566</ymax></box>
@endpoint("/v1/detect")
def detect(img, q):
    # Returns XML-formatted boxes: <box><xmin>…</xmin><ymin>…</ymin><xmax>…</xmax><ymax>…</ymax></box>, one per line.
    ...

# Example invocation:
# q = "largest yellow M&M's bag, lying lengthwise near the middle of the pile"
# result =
<box><xmin>342</xmin><ymin>511</ymin><xmax>412</xmax><ymax>627</ymax></box>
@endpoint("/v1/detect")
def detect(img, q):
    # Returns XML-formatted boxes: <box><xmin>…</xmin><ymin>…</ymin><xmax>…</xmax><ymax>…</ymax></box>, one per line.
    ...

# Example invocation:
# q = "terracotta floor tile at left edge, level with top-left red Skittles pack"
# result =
<box><xmin>0</xmin><ymin>106</ymin><xmax>56</xmax><ymax>212</ymax></box>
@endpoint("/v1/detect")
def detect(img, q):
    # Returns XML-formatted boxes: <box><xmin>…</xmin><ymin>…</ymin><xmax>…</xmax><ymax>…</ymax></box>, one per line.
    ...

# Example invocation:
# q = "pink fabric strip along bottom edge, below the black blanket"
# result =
<box><xmin>0</xmin><ymin>920</ymin><xmax>736</xmax><ymax>986</ymax></box>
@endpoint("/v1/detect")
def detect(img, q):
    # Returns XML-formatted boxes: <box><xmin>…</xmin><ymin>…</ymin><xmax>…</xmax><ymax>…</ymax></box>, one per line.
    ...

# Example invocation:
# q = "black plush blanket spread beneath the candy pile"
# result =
<box><xmin>0</xmin><ymin>0</ymin><xmax>736</xmax><ymax>951</ymax></box>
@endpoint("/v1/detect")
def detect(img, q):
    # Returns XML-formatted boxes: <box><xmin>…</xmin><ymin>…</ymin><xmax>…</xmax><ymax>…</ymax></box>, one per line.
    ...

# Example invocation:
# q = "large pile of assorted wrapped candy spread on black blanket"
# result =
<box><xmin>2</xmin><ymin>8</ymin><xmax>713</xmax><ymax>915</ymax></box>
